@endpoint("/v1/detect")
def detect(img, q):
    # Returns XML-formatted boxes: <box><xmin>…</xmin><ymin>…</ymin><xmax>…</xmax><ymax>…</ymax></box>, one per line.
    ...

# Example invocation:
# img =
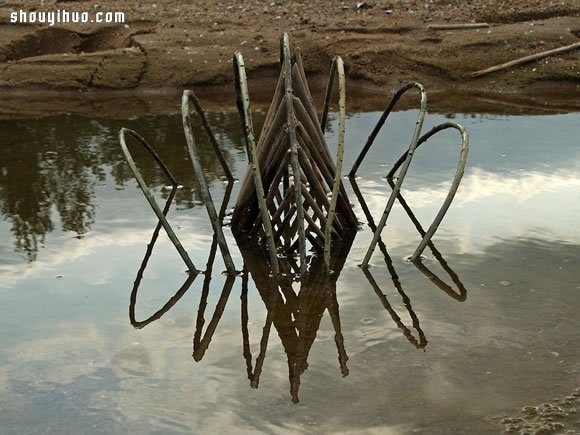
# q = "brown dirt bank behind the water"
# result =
<box><xmin>0</xmin><ymin>0</ymin><xmax>580</xmax><ymax>114</ymax></box>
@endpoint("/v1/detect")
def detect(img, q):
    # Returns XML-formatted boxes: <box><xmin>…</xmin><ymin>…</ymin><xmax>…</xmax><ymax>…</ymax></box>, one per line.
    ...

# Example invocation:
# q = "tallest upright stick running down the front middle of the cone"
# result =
<box><xmin>280</xmin><ymin>33</ymin><xmax>306</xmax><ymax>274</ymax></box>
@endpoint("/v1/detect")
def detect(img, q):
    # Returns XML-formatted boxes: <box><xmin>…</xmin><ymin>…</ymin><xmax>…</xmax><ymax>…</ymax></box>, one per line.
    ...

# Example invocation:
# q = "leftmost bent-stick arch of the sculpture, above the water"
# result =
<box><xmin>119</xmin><ymin>128</ymin><xmax>199</xmax><ymax>275</ymax></box>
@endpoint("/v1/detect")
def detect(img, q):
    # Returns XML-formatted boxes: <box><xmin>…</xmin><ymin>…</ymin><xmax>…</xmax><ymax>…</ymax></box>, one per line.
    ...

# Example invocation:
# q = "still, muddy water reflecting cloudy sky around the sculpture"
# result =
<box><xmin>0</xmin><ymin>106</ymin><xmax>580</xmax><ymax>434</ymax></box>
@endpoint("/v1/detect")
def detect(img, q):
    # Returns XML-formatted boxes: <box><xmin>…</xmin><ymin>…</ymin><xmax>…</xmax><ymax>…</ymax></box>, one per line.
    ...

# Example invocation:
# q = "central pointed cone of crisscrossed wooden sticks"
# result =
<box><xmin>232</xmin><ymin>36</ymin><xmax>357</xmax><ymax>270</ymax></box>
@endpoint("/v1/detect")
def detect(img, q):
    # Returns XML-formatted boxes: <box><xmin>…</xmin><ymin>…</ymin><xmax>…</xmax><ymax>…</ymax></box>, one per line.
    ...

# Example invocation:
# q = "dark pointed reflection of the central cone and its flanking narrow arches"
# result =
<box><xmin>239</xmin><ymin>239</ymin><xmax>352</xmax><ymax>403</ymax></box>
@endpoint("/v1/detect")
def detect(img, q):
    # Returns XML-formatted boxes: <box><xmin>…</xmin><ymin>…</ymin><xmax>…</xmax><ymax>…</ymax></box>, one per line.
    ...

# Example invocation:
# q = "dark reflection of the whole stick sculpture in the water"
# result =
<box><xmin>129</xmin><ymin>179</ymin><xmax>467</xmax><ymax>403</ymax></box>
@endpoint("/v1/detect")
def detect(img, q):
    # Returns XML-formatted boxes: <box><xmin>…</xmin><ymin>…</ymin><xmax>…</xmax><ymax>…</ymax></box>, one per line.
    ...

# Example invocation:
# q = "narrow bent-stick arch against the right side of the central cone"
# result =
<box><xmin>320</xmin><ymin>56</ymin><xmax>346</xmax><ymax>269</ymax></box>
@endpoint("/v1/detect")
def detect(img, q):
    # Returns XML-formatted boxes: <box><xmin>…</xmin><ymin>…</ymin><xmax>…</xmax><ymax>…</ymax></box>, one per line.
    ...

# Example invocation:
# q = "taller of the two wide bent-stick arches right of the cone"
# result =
<box><xmin>360</xmin><ymin>82</ymin><xmax>427</xmax><ymax>268</ymax></box>
